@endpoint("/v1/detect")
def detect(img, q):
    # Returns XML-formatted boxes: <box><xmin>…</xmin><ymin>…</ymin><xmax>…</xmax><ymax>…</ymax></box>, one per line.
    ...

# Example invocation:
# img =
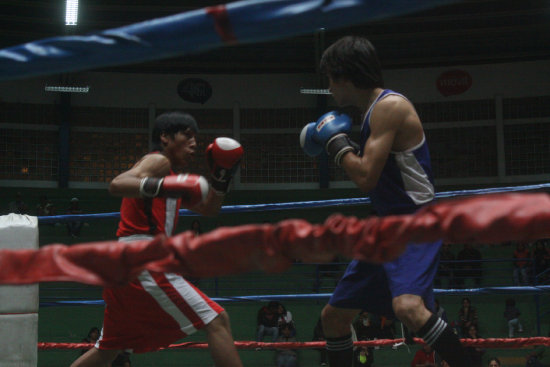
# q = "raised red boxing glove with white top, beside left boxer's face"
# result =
<box><xmin>206</xmin><ymin>138</ymin><xmax>244</xmax><ymax>195</ymax></box>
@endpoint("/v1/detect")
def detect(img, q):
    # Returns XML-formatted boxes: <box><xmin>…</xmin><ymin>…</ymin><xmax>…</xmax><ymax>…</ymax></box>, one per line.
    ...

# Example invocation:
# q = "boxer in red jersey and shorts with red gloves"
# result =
<box><xmin>72</xmin><ymin>112</ymin><xmax>243</xmax><ymax>367</ymax></box>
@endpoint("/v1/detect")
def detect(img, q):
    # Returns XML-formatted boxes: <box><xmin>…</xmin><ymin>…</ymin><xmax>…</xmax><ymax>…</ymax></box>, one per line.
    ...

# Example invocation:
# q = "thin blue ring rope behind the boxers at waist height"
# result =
<box><xmin>38</xmin><ymin>183</ymin><xmax>550</xmax><ymax>224</ymax></box>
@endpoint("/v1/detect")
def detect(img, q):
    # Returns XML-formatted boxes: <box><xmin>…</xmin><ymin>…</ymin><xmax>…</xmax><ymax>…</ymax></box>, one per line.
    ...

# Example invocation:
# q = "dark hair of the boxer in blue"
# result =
<box><xmin>320</xmin><ymin>36</ymin><xmax>384</xmax><ymax>89</ymax></box>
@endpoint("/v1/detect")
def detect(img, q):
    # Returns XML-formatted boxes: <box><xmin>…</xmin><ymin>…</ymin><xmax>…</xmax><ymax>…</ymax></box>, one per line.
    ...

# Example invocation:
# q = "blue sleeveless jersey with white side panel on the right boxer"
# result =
<box><xmin>359</xmin><ymin>89</ymin><xmax>435</xmax><ymax>215</ymax></box>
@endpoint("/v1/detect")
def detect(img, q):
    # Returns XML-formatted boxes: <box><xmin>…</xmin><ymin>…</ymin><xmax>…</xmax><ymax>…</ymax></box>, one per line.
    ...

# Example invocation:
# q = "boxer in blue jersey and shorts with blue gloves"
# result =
<box><xmin>300</xmin><ymin>36</ymin><xmax>469</xmax><ymax>367</ymax></box>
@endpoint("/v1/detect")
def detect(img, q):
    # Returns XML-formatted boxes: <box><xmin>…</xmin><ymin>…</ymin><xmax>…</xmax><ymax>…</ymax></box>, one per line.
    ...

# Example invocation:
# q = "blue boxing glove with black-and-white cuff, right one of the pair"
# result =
<box><xmin>312</xmin><ymin>111</ymin><xmax>357</xmax><ymax>165</ymax></box>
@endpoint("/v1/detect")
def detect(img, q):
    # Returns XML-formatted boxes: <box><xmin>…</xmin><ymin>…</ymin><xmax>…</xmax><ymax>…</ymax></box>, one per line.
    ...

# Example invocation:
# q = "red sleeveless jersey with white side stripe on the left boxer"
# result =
<box><xmin>116</xmin><ymin>160</ymin><xmax>181</xmax><ymax>237</ymax></box>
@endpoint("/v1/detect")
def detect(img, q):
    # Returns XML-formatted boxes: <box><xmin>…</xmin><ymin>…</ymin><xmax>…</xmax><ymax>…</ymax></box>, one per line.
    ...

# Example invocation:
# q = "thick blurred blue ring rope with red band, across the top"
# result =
<box><xmin>0</xmin><ymin>0</ymin><xmax>459</xmax><ymax>80</ymax></box>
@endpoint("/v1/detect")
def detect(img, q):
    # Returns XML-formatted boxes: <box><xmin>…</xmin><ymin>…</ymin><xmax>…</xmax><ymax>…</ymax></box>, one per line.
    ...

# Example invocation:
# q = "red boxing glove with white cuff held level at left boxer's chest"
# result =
<box><xmin>139</xmin><ymin>173</ymin><xmax>210</xmax><ymax>208</ymax></box>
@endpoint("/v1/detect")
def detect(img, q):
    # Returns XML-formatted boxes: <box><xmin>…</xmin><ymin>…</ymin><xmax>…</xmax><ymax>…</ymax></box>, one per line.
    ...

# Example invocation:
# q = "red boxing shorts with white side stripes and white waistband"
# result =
<box><xmin>96</xmin><ymin>235</ymin><xmax>223</xmax><ymax>353</ymax></box>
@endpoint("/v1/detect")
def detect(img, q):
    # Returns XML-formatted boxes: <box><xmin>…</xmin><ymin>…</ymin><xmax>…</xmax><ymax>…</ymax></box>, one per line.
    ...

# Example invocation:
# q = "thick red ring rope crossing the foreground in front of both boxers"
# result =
<box><xmin>0</xmin><ymin>193</ymin><xmax>550</xmax><ymax>286</ymax></box>
